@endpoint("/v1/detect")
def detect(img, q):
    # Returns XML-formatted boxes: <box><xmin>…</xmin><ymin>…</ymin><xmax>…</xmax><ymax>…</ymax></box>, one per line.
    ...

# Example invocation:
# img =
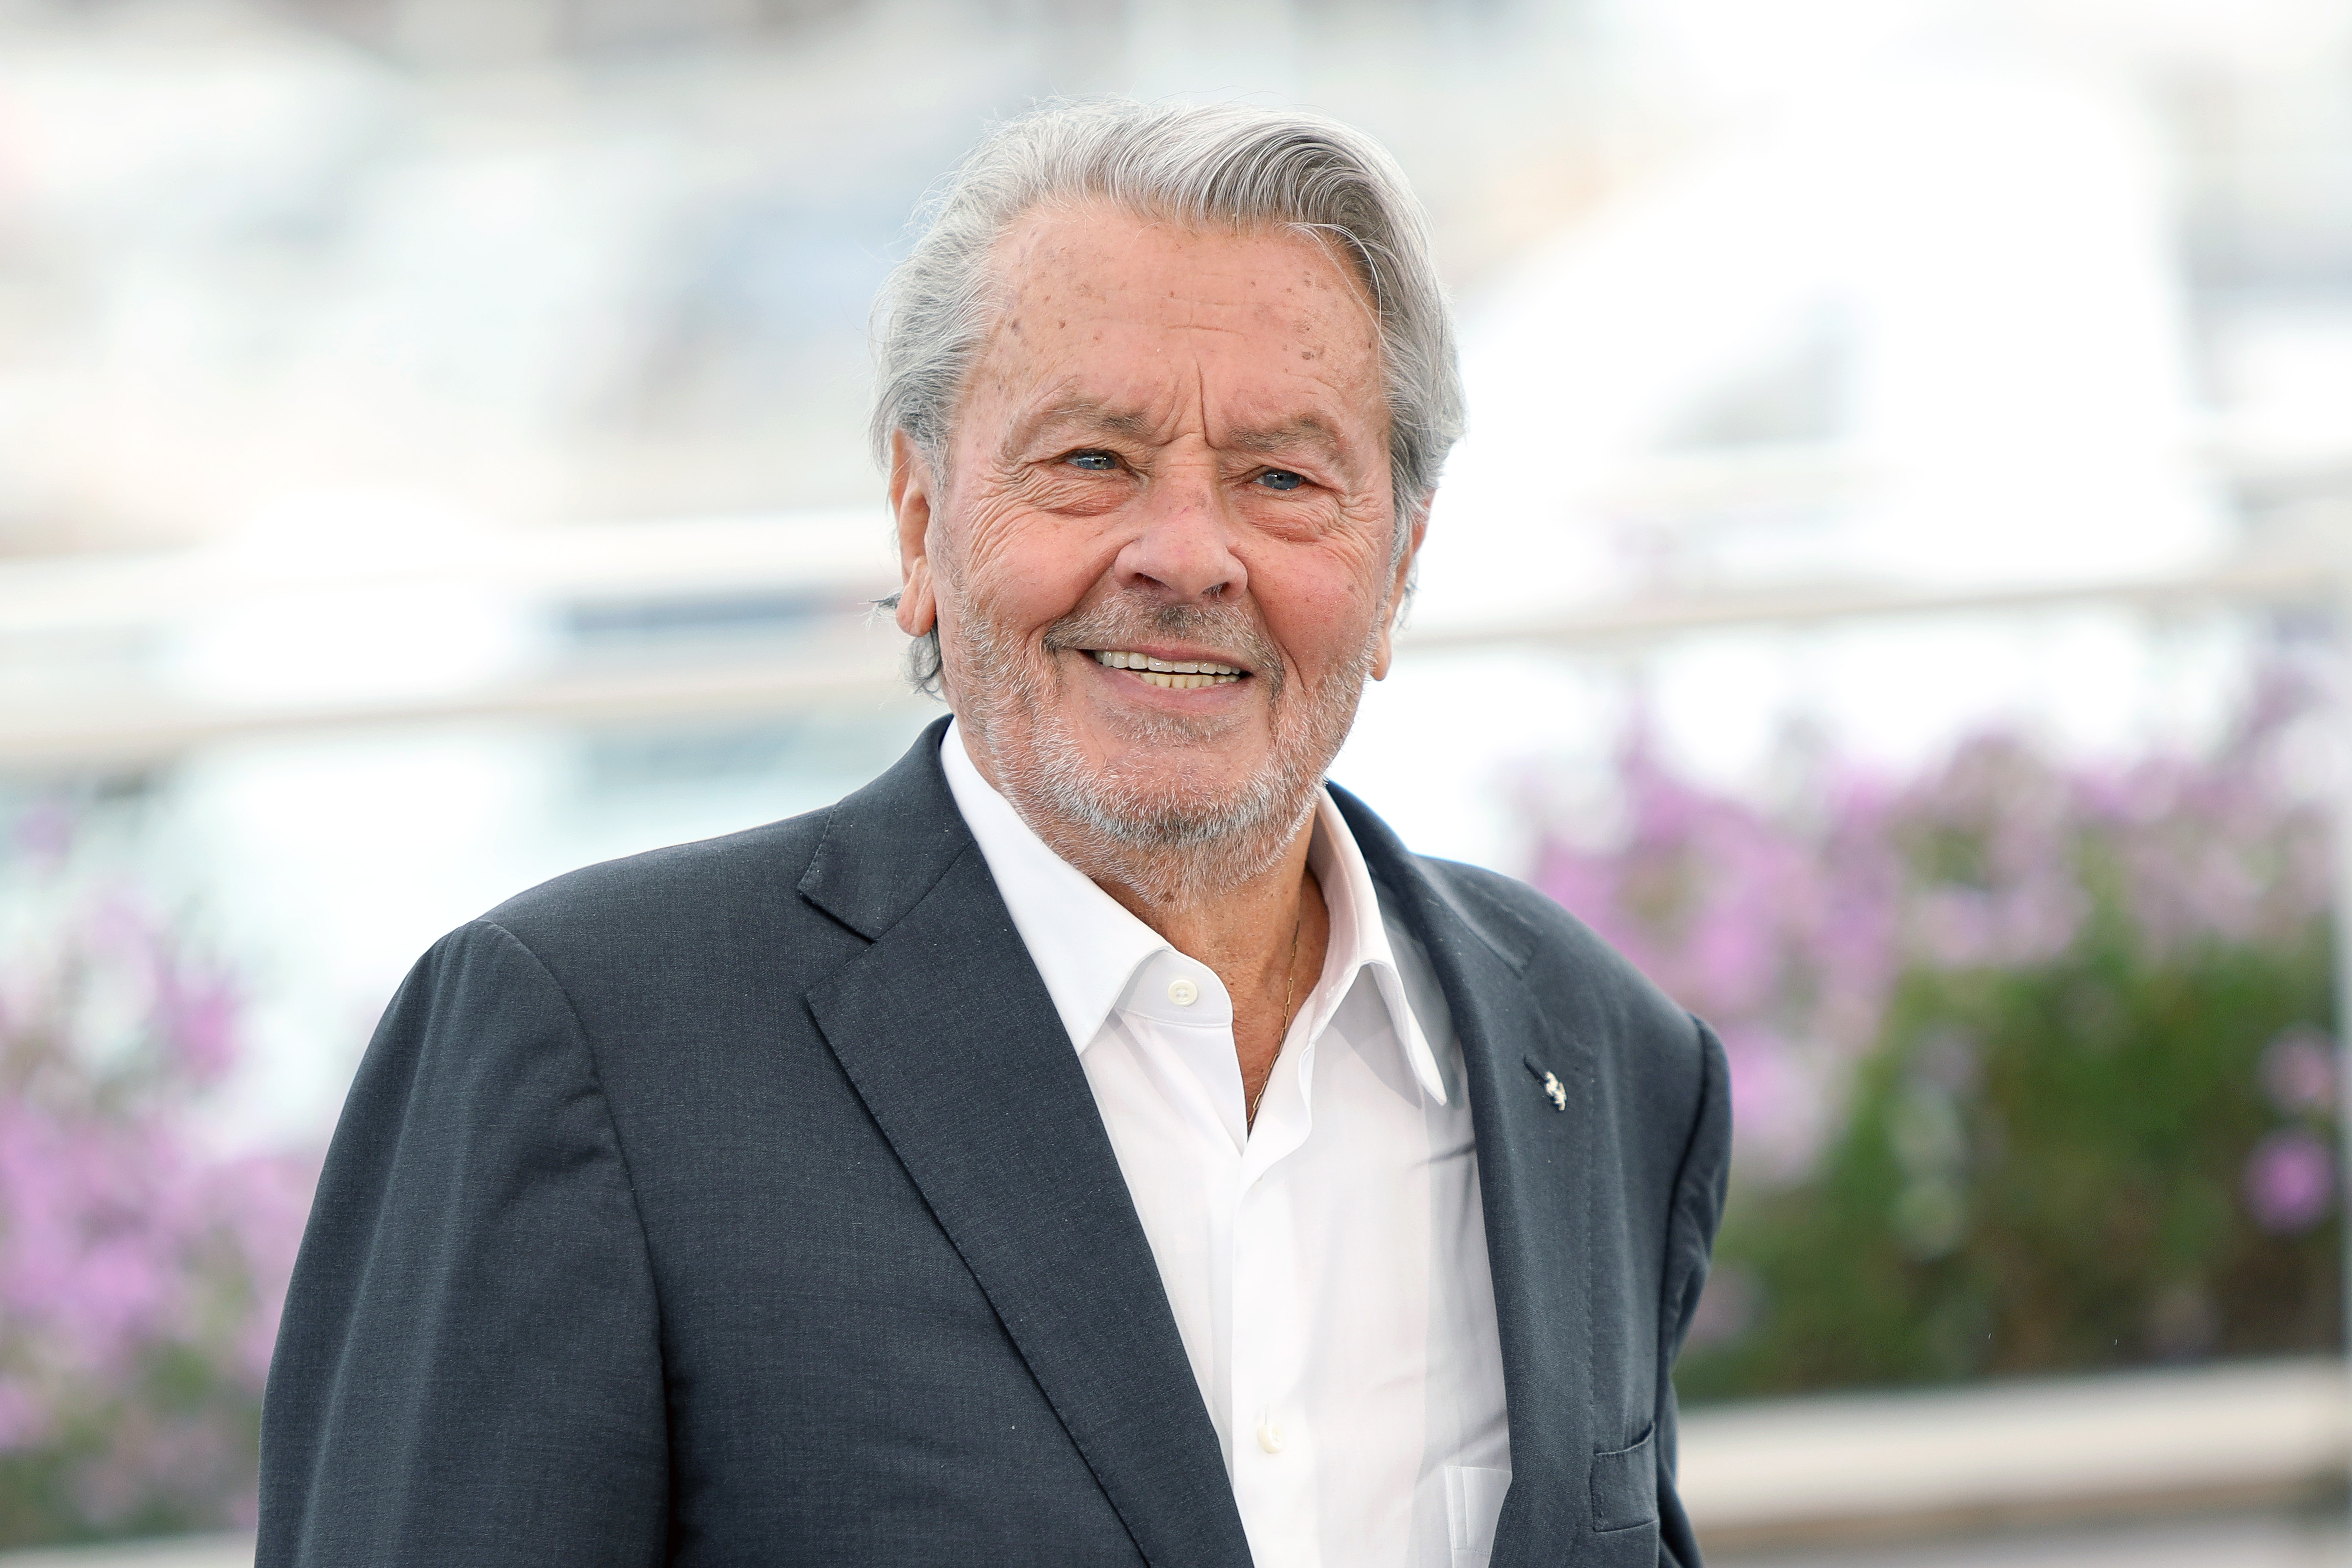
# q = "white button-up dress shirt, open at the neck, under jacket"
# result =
<box><xmin>941</xmin><ymin>724</ymin><xmax>1510</xmax><ymax>1568</ymax></box>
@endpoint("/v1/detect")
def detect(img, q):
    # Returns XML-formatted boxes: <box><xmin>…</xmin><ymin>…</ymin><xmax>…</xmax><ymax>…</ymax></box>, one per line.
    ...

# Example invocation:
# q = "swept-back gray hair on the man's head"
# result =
<box><xmin>870</xmin><ymin>99</ymin><xmax>1463</xmax><ymax>693</ymax></box>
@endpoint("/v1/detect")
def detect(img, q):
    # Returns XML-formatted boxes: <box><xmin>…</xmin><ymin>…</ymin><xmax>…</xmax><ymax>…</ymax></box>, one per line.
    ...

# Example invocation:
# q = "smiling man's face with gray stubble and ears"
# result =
<box><xmin>891</xmin><ymin>207</ymin><xmax>1418</xmax><ymax>884</ymax></box>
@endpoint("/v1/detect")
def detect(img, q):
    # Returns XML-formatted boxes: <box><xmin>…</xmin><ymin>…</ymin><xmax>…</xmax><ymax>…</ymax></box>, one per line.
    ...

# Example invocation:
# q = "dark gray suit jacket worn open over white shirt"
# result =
<box><xmin>261</xmin><ymin>726</ymin><xmax>1731</xmax><ymax>1568</ymax></box>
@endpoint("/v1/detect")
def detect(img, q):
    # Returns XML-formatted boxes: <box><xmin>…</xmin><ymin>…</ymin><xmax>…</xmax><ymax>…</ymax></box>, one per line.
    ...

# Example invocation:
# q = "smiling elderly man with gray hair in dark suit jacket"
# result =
<box><xmin>261</xmin><ymin>104</ymin><xmax>1729</xmax><ymax>1568</ymax></box>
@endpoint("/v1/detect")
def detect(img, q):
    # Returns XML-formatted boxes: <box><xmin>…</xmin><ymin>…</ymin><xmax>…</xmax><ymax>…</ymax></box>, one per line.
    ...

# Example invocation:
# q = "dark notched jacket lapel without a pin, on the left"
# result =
<box><xmin>800</xmin><ymin>724</ymin><xmax>1249</xmax><ymax>1568</ymax></box>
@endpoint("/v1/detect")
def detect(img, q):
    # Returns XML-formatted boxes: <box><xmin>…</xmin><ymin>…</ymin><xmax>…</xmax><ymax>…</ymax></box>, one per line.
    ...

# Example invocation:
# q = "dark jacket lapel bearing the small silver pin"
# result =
<box><xmin>1331</xmin><ymin>788</ymin><xmax>1595</xmax><ymax>1568</ymax></box>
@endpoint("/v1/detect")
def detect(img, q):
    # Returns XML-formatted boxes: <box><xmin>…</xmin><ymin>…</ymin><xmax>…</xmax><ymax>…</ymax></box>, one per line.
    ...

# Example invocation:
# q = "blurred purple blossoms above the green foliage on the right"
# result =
<box><xmin>1533</xmin><ymin>689</ymin><xmax>2333</xmax><ymax>1180</ymax></box>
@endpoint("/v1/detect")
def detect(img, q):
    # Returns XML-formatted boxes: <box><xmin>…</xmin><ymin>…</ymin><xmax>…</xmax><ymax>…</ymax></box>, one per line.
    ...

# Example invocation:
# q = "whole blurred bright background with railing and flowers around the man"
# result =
<box><xmin>0</xmin><ymin>0</ymin><xmax>2352</xmax><ymax>1568</ymax></box>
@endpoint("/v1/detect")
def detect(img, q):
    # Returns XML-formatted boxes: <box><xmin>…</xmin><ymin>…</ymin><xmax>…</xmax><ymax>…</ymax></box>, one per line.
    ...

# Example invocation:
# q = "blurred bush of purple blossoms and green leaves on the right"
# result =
<box><xmin>1536</xmin><ymin>691</ymin><xmax>2343</xmax><ymax>1399</ymax></box>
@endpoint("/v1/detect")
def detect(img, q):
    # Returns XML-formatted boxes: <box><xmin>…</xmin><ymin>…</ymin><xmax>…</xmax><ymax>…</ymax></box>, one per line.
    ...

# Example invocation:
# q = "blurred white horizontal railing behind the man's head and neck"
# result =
<box><xmin>0</xmin><ymin>531</ymin><xmax>2343</xmax><ymax>771</ymax></box>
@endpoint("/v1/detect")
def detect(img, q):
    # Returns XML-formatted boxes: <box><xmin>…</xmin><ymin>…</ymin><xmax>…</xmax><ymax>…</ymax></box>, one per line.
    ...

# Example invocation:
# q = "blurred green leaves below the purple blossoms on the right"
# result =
<box><xmin>1677</xmin><ymin>921</ymin><xmax>2340</xmax><ymax>1399</ymax></box>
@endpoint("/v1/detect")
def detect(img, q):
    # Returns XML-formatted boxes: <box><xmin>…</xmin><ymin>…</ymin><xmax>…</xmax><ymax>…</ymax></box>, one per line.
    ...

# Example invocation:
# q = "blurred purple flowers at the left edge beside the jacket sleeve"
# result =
<box><xmin>0</xmin><ymin>879</ymin><xmax>317</xmax><ymax>1528</ymax></box>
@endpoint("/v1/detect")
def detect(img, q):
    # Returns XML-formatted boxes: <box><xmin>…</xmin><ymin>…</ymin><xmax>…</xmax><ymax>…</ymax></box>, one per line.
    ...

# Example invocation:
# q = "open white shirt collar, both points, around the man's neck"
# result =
<box><xmin>938</xmin><ymin>724</ymin><xmax>1447</xmax><ymax>1105</ymax></box>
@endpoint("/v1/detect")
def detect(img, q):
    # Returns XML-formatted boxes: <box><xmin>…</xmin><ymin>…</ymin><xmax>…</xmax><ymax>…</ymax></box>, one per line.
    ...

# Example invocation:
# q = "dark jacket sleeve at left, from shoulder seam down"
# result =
<box><xmin>259</xmin><ymin>922</ymin><xmax>668</xmax><ymax>1568</ymax></box>
